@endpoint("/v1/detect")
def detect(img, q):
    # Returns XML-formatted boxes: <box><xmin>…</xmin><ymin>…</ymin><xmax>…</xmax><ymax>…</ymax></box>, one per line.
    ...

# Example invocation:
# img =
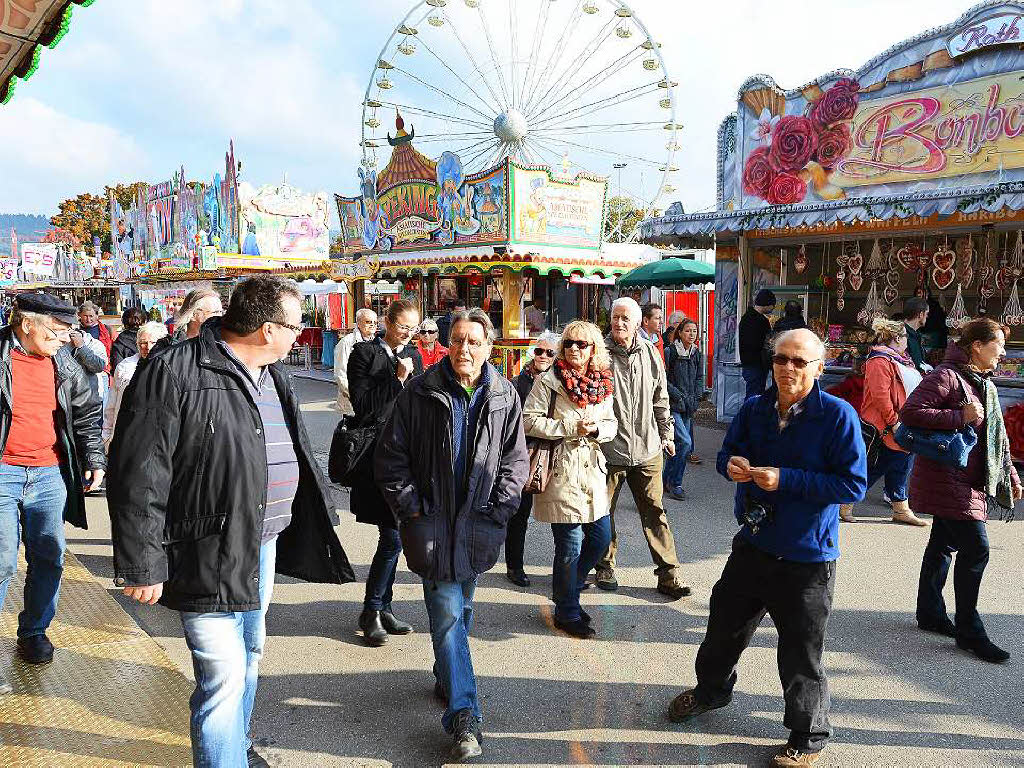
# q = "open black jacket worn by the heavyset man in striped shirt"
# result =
<box><xmin>106</xmin><ymin>318</ymin><xmax>355</xmax><ymax>611</ymax></box>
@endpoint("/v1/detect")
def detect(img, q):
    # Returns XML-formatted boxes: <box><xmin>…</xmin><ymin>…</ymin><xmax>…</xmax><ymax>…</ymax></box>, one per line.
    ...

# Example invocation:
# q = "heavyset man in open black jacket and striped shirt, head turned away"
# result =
<box><xmin>108</xmin><ymin>276</ymin><xmax>354</xmax><ymax>766</ymax></box>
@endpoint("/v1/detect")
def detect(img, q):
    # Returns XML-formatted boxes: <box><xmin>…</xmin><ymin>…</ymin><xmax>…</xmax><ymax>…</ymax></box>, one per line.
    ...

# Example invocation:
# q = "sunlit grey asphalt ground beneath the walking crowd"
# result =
<box><xmin>69</xmin><ymin>379</ymin><xmax>1024</xmax><ymax>766</ymax></box>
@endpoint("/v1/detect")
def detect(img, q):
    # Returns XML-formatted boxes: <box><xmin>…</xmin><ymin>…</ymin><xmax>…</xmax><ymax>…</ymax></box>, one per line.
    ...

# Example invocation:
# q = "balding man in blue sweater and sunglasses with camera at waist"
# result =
<box><xmin>669</xmin><ymin>329</ymin><xmax>867</xmax><ymax>766</ymax></box>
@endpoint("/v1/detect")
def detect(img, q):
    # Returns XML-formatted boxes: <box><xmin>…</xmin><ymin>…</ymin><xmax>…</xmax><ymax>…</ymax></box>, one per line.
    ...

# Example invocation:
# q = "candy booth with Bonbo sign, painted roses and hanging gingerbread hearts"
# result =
<box><xmin>642</xmin><ymin>2</ymin><xmax>1024</xmax><ymax>419</ymax></box>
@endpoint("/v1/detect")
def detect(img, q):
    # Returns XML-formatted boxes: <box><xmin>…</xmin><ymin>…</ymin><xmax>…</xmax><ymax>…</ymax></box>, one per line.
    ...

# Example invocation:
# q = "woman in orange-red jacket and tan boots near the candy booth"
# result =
<box><xmin>839</xmin><ymin>317</ymin><xmax>928</xmax><ymax>526</ymax></box>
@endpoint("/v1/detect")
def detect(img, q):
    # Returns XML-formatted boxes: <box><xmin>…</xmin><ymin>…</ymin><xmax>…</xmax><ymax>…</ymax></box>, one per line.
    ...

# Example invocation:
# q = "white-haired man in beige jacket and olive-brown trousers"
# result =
<box><xmin>597</xmin><ymin>298</ymin><xmax>690</xmax><ymax>600</ymax></box>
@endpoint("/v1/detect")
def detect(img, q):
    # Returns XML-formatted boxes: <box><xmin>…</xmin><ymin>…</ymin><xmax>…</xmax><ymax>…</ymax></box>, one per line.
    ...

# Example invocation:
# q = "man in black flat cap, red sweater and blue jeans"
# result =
<box><xmin>0</xmin><ymin>294</ymin><xmax>105</xmax><ymax>693</ymax></box>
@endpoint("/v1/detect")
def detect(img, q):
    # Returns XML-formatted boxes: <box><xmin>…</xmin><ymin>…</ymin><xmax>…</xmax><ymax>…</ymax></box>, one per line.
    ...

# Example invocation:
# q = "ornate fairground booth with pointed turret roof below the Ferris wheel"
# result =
<box><xmin>336</xmin><ymin>116</ymin><xmax>656</xmax><ymax>374</ymax></box>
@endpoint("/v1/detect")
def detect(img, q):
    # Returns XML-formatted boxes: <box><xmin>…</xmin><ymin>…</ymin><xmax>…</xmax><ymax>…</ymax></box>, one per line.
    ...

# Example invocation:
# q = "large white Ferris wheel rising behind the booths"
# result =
<box><xmin>360</xmin><ymin>0</ymin><xmax>682</xmax><ymax>242</ymax></box>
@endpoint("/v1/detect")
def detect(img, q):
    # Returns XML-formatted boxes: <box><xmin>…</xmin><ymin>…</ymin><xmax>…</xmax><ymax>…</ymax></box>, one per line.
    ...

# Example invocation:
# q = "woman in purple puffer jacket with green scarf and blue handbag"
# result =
<box><xmin>900</xmin><ymin>318</ymin><xmax>1022</xmax><ymax>663</ymax></box>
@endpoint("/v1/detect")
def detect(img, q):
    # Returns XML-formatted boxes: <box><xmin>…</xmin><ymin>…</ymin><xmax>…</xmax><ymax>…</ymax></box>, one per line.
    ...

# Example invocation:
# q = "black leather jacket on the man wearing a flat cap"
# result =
<box><xmin>0</xmin><ymin>326</ymin><xmax>106</xmax><ymax>528</ymax></box>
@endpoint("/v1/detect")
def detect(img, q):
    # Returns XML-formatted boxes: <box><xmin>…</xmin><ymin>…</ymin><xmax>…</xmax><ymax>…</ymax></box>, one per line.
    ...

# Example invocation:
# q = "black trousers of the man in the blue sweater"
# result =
<box><xmin>696</xmin><ymin>536</ymin><xmax>836</xmax><ymax>752</ymax></box>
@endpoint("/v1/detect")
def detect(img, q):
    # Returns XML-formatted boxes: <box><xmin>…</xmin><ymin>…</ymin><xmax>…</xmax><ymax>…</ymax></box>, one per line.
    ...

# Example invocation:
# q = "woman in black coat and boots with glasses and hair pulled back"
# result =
<box><xmin>347</xmin><ymin>300</ymin><xmax>423</xmax><ymax>646</ymax></box>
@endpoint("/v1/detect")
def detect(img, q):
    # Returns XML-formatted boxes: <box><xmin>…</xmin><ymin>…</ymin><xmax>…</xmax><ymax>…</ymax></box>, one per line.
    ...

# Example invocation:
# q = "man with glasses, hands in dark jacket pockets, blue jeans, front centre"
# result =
<box><xmin>375</xmin><ymin>309</ymin><xmax>529</xmax><ymax>761</ymax></box>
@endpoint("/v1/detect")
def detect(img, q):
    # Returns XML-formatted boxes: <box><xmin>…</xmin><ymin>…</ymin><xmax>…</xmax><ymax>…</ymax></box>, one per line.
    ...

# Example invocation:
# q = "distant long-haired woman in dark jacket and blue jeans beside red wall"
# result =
<box><xmin>662</xmin><ymin>319</ymin><xmax>703</xmax><ymax>501</ymax></box>
